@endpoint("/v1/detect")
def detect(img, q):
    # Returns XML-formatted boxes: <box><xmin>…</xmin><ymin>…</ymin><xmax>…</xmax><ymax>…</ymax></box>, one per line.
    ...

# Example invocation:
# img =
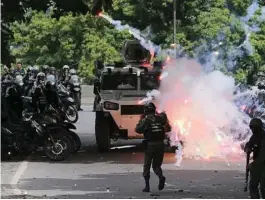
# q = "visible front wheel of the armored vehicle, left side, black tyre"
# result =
<box><xmin>95</xmin><ymin>112</ymin><xmax>110</xmax><ymax>153</ymax></box>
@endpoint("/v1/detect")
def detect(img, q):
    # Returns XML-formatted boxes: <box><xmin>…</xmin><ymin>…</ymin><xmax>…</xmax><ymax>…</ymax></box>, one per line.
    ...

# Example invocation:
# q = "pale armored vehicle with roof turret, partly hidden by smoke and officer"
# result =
<box><xmin>94</xmin><ymin>41</ymin><xmax>162</xmax><ymax>152</ymax></box>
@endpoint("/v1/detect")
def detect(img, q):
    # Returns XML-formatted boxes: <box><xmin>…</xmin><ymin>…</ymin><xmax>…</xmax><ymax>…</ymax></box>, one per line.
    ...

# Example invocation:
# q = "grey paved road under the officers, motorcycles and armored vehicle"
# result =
<box><xmin>1</xmin><ymin>106</ymin><xmax>248</xmax><ymax>199</ymax></box>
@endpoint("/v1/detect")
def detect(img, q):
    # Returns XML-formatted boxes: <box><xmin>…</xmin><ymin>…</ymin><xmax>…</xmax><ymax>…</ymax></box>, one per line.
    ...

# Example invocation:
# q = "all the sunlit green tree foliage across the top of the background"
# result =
<box><xmin>7</xmin><ymin>0</ymin><xmax>265</xmax><ymax>83</ymax></box>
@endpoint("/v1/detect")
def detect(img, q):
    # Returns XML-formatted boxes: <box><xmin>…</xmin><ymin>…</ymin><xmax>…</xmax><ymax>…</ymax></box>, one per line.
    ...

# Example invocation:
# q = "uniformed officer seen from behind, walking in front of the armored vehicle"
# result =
<box><xmin>135</xmin><ymin>103</ymin><xmax>171</xmax><ymax>192</ymax></box>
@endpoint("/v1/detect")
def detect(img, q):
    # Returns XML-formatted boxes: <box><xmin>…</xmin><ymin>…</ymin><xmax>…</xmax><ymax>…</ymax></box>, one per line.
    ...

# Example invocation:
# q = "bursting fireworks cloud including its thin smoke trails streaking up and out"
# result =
<box><xmin>99</xmin><ymin>0</ymin><xmax>265</xmax><ymax>165</ymax></box>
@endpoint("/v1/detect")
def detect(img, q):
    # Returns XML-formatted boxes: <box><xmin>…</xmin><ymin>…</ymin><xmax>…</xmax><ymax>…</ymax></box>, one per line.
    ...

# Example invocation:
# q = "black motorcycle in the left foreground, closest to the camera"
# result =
<box><xmin>2</xmin><ymin>109</ymin><xmax>73</xmax><ymax>161</ymax></box>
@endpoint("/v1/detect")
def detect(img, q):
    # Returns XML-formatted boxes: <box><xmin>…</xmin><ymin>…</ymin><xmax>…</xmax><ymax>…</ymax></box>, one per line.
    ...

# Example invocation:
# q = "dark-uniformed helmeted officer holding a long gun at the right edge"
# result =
<box><xmin>245</xmin><ymin>118</ymin><xmax>265</xmax><ymax>199</ymax></box>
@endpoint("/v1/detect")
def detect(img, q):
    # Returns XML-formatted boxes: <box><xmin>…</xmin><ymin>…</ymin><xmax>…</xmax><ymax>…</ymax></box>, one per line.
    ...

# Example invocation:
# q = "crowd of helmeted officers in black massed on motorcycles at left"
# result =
<box><xmin>1</xmin><ymin>63</ymin><xmax>82</xmax><ymax>119</ymax></box>
